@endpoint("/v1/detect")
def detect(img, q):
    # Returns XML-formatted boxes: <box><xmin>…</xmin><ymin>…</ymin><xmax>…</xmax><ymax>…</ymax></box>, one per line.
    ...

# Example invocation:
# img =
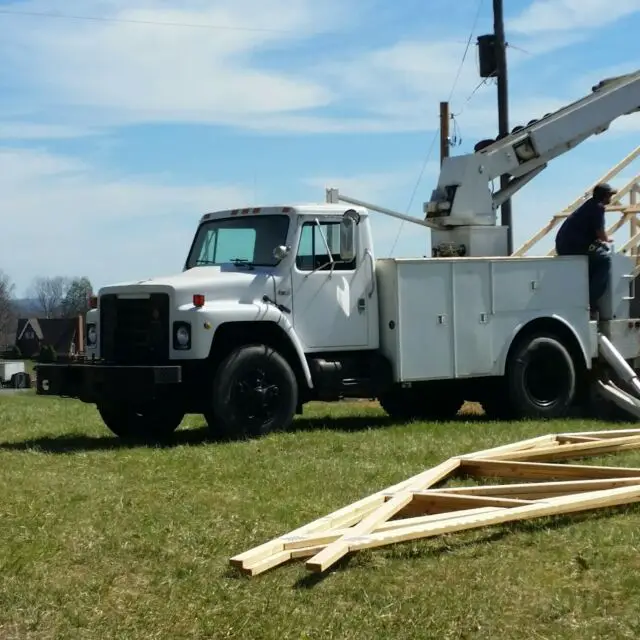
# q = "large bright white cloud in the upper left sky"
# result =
<box><xmin>0</xmin><ymin>0</ymin><xmax>344</xmax><ymax>129</ymax></box>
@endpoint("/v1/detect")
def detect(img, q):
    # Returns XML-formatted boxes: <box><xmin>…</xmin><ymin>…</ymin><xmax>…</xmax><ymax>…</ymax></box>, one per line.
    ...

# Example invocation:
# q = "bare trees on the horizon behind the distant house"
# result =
<box><xmin>0</xmin><ymin>269</ymin><xmax>93</xmax><ymax>348</ymax></box>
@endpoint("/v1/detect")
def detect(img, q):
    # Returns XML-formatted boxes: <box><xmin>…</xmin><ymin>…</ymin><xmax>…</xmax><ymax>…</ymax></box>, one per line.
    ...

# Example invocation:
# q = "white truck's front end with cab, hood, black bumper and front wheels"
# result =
<box><xmin>38</xmin><ymin>203</ymin><xmax>390</xmax><ymax>436</ymax></box>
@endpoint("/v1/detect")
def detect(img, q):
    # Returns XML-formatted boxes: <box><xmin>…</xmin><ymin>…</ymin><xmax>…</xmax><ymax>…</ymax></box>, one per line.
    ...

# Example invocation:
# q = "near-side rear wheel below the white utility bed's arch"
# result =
<box><xmin>503</xmin><ymin>333</ymin><xmax>578</xmax><ymax>419</ymax></box>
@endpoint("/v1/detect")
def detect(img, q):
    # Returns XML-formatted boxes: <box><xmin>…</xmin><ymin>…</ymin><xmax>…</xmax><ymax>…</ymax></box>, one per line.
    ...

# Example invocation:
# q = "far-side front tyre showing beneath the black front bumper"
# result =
<box><xmin>97</xmin><ymin>402</ymin><xmax>185</xmax><ymax>441</ymax></box>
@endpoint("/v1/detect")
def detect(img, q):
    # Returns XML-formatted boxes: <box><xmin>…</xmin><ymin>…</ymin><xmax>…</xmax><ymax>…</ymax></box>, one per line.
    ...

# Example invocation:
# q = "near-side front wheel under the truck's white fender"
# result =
<box><xmin>211</xmin><ymin>345</ymin><xmax>298</xmax><ymax>438</ymax></box>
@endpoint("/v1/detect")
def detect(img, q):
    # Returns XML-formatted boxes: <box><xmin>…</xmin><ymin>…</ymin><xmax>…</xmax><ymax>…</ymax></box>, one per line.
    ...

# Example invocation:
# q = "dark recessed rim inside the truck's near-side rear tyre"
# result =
<box><xmin>523</xmin><ymin>346</ymin><xmax>570</xmax><ymax>407</ymax></box>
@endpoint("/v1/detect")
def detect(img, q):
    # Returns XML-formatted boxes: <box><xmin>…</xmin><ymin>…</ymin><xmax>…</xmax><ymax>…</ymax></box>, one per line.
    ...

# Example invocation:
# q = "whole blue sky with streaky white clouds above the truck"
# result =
<box><xmin>0</xmin><ymin>0</ymin><xmax>640</xmax><ymax>294</ymax></box>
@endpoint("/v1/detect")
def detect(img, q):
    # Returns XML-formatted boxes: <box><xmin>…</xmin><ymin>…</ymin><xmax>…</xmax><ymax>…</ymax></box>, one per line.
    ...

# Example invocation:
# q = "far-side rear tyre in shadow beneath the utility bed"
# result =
<box><xmin>378</xmin><ymin>386</ymin><xmax>462</xmax><ymax>422</ymax></box>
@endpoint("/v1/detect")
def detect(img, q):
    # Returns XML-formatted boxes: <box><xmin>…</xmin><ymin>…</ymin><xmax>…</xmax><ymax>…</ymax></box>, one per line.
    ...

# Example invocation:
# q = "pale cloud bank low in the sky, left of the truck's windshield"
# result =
<box><xmin>0</xmin><ymin>149</ymin><xmax>253</xmax><ymax>291</ymax></box>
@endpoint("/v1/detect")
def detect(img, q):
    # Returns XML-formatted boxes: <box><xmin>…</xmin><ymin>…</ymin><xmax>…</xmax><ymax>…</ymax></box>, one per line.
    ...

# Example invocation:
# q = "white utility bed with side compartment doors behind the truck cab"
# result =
<box><xmin>376</xmin><ymin>256</ymin><xmax>596</xmax><ymax>382</ymax></box>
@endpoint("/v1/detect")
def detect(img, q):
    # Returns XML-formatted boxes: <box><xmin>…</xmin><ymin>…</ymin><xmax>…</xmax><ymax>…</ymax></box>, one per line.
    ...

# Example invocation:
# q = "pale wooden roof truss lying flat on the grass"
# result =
<box><xmin>230</xmin><ymin>429</ymin><xmax>640</xmax><ymax>576</ymax></box>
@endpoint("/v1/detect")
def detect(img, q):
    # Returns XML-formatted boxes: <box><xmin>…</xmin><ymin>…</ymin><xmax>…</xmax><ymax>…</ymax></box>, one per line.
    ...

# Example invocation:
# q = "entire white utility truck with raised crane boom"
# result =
<box><xmin>37</xmin><ymin>71</ymin><xmax>640</xmax><ymax>439</ymax></box>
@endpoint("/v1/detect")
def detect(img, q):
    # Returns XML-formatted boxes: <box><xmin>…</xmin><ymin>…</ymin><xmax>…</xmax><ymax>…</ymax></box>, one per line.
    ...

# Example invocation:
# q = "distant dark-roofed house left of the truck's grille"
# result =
<box><xmin>16</xmin><ymin>316</ymin><xmax>84</xmax><ymax>358</ymax></box>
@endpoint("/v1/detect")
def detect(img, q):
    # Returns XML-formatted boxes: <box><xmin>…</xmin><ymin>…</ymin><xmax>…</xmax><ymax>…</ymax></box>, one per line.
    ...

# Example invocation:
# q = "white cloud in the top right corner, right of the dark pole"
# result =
<box><xmin>506</xmin><ymin>0</ymin><xmax>640</xmax><ymax>34</ymax></box>
